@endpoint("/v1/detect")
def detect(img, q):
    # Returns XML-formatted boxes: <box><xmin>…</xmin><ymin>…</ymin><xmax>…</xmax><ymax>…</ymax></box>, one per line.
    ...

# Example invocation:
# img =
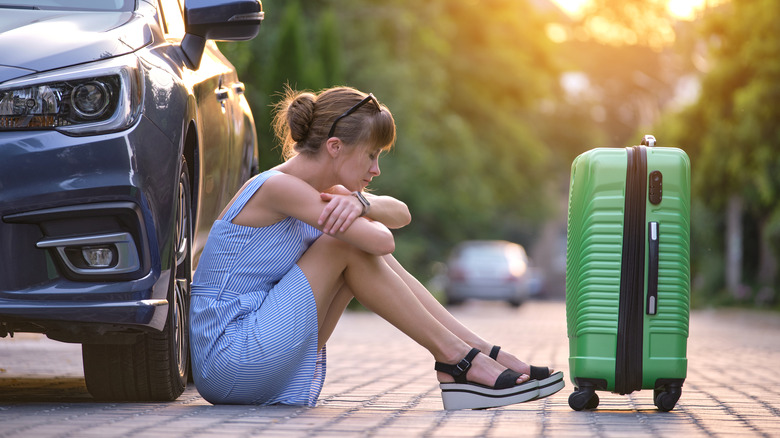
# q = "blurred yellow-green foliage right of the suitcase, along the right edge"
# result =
<box><xmin>667</xmin><ymin>0</ymin><xmax>780</xmax><ymax>303</ymax></box>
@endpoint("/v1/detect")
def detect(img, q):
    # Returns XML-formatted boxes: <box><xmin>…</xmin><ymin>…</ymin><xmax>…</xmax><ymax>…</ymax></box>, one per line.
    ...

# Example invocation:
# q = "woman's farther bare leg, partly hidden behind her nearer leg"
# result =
<box><xmin>384</xmin><ymin>255</ymin><xmax>553</xmax><ymax>374</ymax></box>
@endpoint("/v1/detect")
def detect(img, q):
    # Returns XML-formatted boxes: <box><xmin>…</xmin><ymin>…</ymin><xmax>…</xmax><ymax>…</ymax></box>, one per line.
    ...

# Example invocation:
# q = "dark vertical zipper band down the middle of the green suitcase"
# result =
<box><xmin>615</xmin><ymin>146</ymin><xmax>647</xmax><ymax>394</ymax></box>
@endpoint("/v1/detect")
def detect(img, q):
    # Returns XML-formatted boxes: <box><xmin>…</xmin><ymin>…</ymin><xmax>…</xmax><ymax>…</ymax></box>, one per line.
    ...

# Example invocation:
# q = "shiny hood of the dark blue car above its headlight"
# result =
<box><xmin>0</xmin><ymin>9</ymin><xmax>152</xmax><ymax>83</ymax></box>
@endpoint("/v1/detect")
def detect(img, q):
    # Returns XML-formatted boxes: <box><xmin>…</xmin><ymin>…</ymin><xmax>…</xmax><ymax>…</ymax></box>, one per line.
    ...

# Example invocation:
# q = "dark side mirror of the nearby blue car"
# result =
<box><xmin>181</xmin><ymin>0</ymin><xmax>264</xmax><ymax>69</ymax></box>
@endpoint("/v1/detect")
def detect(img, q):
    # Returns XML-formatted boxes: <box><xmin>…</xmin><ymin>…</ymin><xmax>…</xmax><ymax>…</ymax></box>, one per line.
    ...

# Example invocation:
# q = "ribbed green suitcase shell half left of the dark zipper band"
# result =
<box><xmin>566</xmin><ymin>148</ymin><xmax>626</xmax><ymax>389</ymax></box>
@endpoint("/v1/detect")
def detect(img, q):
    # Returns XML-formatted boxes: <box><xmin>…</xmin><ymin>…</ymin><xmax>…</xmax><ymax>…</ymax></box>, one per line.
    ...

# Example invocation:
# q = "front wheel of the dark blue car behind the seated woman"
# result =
<box><xmin>82</xmin><ymin>157</ymin><xmax>192</xmax><ymax>401</ymax></box>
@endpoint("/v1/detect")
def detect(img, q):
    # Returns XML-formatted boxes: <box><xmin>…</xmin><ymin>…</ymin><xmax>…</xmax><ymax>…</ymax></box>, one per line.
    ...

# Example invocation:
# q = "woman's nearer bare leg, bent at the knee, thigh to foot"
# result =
<box><xmin>298</xmin><ymin>235</ymin><xmax>525</xmax><ymax>386</ymax></box>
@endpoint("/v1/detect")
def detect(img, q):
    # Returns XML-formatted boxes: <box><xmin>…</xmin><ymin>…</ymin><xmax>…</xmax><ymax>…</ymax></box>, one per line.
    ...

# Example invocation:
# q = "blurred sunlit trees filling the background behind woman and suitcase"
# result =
<box><xmin>220</xmin><ymin>0</ymin><xmax>780</xmax><ymax>310</ymax></box>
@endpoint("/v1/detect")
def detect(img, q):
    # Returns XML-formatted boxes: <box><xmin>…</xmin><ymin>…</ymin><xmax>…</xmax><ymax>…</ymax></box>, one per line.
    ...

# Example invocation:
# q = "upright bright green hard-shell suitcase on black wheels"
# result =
<box><xmin>566</xmin><ymin>135</ymin><xmax>690</xmax><ymax>411</ymax></box>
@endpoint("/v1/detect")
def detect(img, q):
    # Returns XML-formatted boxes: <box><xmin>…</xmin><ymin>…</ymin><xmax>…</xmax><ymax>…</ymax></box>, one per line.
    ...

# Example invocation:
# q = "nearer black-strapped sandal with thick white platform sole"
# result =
<box><xmin>434</xmin><ymin>348</ymin><xmax>539</xmax><ymax>410</ymax></box>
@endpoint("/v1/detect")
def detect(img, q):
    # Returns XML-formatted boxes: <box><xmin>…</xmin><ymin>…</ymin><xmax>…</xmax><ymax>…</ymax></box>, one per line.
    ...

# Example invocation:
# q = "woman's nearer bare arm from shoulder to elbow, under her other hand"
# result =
<box><xmin>238</xmin><ymin>174</ymin><xmax>395</xmax><ymax>255</ymax></box>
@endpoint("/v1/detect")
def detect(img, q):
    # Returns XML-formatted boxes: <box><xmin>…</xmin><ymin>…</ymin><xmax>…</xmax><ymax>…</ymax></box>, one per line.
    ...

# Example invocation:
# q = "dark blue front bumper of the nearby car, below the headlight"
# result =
<box><xmin>0</xmin><ymin>118</ymin><xmax>179</xmax><ymax>342</ymax></box>
